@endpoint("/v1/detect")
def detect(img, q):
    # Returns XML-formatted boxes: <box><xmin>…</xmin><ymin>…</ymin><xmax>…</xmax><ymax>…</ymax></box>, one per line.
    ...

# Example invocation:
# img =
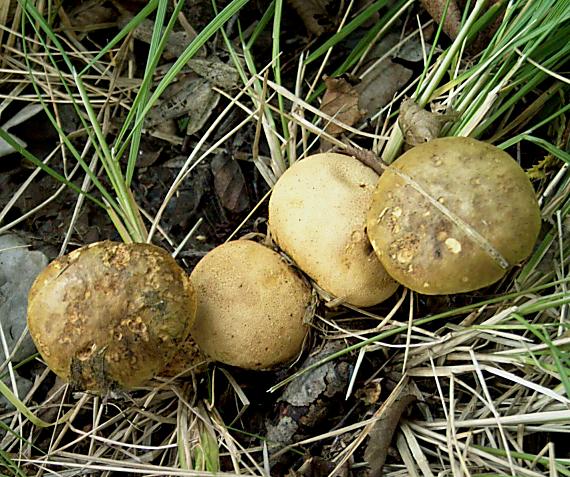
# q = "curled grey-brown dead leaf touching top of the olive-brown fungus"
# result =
<box><xmin>398</xmin><ymin>98</ymin><xmax>457</xmax><ymax>147</ymax></box>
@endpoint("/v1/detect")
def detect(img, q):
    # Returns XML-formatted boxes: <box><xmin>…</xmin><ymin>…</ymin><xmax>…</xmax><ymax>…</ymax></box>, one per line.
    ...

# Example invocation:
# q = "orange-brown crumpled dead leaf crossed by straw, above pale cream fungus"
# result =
<box><xmin>320</xmin><ymin>77</ymin><xmax>363</xmax><ymax>136</ymax></box>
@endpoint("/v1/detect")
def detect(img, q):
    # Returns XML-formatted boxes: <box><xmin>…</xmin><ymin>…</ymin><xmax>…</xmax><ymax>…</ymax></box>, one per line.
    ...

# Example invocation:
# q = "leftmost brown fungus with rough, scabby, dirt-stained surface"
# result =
<box><xmin>28</xmin><ymin>241</ymin><xmax>196</xmax><ymax>392</ymax></box>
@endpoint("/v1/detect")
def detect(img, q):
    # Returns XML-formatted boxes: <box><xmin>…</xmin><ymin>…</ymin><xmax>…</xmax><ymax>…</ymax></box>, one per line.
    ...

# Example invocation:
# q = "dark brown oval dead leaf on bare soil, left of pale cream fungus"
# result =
<box><xmin>211</xmin><ymin>154</ymin><xmax>249</xmax><ymax>214</ymax></box>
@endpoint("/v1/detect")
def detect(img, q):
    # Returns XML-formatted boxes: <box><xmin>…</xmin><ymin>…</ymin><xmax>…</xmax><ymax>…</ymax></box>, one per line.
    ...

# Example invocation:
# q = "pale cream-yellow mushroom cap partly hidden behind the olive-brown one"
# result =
<box><xmin>269</xmin><ymin>153</ymin><xmax>398</xmax><ymax>306</ymax></box>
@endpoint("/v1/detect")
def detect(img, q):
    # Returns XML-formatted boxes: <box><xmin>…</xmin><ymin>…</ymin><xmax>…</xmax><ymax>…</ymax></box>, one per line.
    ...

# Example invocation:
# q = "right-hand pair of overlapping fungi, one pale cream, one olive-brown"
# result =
<box><xmin>269</xmin><ymin>137</ymin><xmax>541</xmax><ymax>306</ymax></box>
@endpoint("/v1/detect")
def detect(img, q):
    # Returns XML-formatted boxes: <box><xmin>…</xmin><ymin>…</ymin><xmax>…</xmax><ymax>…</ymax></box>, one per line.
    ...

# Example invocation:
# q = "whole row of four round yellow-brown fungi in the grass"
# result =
<box><xmin>28</xmin><ymin>138</ymin><xmax>541</xmax><ymax>390</ymax></box>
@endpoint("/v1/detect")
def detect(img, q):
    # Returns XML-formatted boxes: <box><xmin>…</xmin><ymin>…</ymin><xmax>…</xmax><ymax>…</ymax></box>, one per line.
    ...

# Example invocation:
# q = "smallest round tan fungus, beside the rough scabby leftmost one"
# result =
<box><xmin>190</xmin><ymin>240</ymin><xmax>311</xmax><ymax>369</ymax></box>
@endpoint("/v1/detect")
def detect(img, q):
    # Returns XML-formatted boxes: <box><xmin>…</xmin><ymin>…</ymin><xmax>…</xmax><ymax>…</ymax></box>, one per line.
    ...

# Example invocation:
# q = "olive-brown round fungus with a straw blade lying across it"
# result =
<box><xmin>367</xmin><ymin>137</ymin><xmax>541</xmax><ymax>295</ymax></box>
